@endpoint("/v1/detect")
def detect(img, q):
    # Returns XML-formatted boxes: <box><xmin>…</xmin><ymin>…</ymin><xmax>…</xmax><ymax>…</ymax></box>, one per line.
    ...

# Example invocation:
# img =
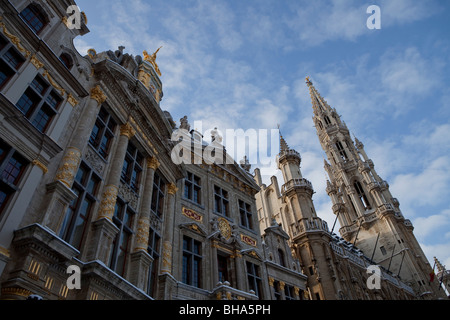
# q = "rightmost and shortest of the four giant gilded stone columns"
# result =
<box><xmin>160</xmin><ymin>183</ymin><xmax>178</xmax><ymax>275</ymax></box>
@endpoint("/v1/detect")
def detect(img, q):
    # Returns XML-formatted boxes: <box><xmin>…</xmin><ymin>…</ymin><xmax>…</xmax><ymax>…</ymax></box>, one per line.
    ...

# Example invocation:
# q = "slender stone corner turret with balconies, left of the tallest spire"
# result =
<box><xmin>277</xmin><ymin>134</ymin><xmax>336</xmax><ymax>300</ymax></box>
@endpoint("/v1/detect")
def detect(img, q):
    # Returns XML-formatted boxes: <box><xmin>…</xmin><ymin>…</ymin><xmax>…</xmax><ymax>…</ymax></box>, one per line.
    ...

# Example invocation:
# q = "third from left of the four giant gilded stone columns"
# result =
<box><xmin>130</xmin><ymin>157</ymin><xmax>159</xmax><ymax>291</ymax></box>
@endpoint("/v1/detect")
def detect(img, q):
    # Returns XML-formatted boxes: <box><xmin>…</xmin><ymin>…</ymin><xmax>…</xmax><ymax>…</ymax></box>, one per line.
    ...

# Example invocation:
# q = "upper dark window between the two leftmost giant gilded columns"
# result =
<box><xmin>89</xmin><ymin>106</ymin><xmax>117</xmax><ymax>159</ymax></box>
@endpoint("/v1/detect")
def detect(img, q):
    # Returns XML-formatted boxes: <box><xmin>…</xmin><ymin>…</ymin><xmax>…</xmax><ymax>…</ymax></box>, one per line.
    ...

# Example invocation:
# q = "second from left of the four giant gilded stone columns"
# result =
<box><xmin>86</xmin><ymin>123</ymin><xmax>135</xmax><ymax>264</ymax></box>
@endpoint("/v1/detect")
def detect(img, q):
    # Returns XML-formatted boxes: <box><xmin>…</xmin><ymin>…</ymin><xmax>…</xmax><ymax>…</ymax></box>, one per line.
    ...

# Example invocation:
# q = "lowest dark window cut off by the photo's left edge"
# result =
<box><xmin>0</xmin><ymin>140</ymin><xmax>29</xmax><ymax>217</ymax></box>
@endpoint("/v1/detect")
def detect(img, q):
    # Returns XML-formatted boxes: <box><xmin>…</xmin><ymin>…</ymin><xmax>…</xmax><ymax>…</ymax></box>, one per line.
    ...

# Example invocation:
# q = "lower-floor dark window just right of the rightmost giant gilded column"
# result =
<box><xmin>182</xmin><ymin>236</ymin><xmax>202</xmax><ymax>288</ymax></box>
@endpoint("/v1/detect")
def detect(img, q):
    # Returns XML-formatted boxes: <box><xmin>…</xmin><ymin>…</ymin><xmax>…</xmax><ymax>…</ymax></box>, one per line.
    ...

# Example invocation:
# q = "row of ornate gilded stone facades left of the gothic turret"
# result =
<box><xmin>0</xmin><ymin>0</ymin><xmax>306</xmax><ymax>300</ymax></box>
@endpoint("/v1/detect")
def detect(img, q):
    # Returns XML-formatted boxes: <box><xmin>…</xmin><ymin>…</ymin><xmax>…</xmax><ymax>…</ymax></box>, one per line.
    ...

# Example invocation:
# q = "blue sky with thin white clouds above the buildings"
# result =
<box><xmin>75</xmin><ymin>0</ymin><xmax>450</xmax><ymax>267</ymax></box>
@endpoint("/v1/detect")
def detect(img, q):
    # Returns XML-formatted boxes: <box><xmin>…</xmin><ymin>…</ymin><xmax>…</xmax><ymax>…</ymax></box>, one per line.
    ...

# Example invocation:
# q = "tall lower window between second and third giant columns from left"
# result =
<box><xmin>109</xmin><ymin>198</ymin><xmax>135</xmax><ymax>276</ymax></box>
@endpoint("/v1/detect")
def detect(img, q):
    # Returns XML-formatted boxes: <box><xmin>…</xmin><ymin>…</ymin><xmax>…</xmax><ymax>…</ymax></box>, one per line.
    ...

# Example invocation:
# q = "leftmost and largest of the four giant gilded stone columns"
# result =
<box><xmin>42</xmin><ymin>85</ymin><xmax>106</xmax><ymax>233</ymax></box>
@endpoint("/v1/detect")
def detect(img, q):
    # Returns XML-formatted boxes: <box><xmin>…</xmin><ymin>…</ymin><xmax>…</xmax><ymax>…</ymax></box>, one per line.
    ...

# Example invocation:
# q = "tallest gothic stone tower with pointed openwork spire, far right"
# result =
<box><xmin>306</xmin><ymin>78</ymin><xmax>442</xmax><ymax>298</ymax></box>
